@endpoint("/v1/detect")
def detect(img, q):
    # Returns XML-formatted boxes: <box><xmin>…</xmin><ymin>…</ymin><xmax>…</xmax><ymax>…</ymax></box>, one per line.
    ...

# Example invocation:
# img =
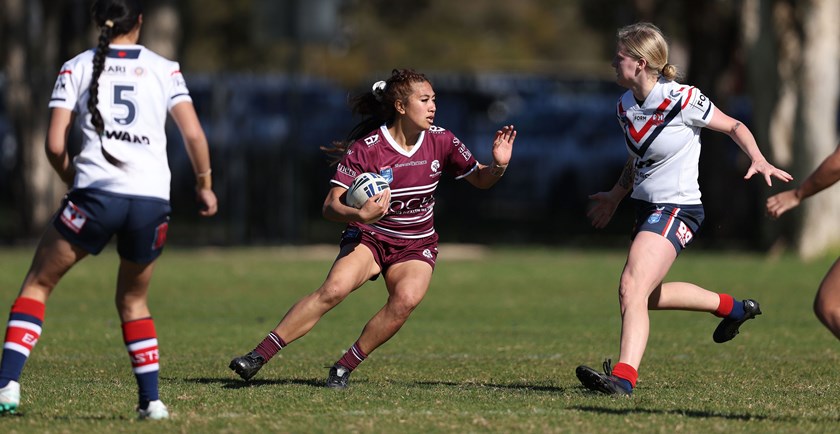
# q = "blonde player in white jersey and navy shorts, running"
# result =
<box><xmin>576</xmin><ymin>23</ymin><xmax>792</xmax><ymax>395</ymax></box>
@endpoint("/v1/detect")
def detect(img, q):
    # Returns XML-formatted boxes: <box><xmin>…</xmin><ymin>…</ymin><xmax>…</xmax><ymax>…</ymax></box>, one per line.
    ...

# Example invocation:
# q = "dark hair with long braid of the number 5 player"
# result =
<box><xmin>87</xmin><ymin>0</ymin><xmax>143</xmax><ymax>136</ymax></box>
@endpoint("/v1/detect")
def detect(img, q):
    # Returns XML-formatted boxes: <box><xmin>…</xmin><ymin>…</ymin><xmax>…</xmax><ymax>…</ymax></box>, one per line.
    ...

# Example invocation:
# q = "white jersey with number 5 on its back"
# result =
<box><xmin>49</xmin><ymin>45</ymin><xmax>192</xmax><ymax>200</ymax></box>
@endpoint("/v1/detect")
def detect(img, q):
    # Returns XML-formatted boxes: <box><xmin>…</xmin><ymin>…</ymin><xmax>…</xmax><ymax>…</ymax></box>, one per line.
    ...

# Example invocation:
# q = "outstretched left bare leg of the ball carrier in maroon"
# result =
<box><xmin>274</xmin><ymin>244</ymin><xmax>379</xmax><ymax>344</ymax></box>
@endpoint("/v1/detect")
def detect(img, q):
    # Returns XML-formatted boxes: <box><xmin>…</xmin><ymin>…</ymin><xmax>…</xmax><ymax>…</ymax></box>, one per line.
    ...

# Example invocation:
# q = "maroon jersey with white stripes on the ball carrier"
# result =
<box><xmin>330</xmin><ymin>125</ymin><xmax>478</xmax><ymax>239</ymax></box>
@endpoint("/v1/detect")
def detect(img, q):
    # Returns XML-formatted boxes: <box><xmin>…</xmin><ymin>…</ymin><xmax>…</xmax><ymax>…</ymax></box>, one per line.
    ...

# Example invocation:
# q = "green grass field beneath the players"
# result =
<box><xmin>0</xmin><ymin>246</ymin><xmax>840</xmax><ymax>434</ymax></box>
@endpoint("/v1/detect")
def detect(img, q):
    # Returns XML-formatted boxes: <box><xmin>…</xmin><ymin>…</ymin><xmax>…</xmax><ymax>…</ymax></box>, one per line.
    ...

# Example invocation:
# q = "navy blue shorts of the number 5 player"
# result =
<box><xmin>53</xmin><ymin>189</ymin><xmax>172</xmax><ymax>264</ymax></box>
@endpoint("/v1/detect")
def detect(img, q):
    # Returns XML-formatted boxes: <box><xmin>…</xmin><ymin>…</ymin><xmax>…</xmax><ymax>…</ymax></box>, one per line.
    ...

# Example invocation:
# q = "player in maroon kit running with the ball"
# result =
<box><xmin>229</xmin><ymin>69</ymin><xmax>516</xmax><ymax>389</ymax></box>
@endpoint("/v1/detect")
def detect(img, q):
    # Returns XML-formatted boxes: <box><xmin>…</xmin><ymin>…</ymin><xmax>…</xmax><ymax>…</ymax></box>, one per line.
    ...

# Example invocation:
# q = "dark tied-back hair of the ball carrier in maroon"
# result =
<box><xmin>321</xmin><ymin>69</ymin><xmax>431</xmax><ymax>164</ymax></box>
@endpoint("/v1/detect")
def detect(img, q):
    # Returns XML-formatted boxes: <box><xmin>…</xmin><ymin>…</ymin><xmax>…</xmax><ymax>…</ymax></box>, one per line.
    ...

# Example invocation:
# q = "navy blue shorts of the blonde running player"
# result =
<box><xmin>632</xmin><ymin>200</ymin><xmax>706</xmax><ymax>254</ymax></box>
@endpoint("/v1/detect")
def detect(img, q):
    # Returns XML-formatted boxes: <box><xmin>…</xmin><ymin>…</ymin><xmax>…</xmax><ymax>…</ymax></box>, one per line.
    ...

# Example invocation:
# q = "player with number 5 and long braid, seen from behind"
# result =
<box><xmin>0</xmin><ymin>0</ymin><xmax>217</xmax><ymax>419</ymax></box>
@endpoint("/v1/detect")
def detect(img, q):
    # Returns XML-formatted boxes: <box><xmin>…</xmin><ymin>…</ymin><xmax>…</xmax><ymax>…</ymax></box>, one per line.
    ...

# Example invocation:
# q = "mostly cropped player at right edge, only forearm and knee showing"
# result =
<box><xmin>766</xmin><ymin>145</ymin><xmax>840</xmax><ymax>339</ymax></box>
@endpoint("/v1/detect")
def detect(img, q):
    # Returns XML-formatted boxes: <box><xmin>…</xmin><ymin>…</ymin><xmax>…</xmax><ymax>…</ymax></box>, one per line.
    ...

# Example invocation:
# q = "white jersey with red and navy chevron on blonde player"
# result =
<box><xmin>616</xmin><ymin>79</ymin><xmax>715</xmax><ymax>205</ymax></box>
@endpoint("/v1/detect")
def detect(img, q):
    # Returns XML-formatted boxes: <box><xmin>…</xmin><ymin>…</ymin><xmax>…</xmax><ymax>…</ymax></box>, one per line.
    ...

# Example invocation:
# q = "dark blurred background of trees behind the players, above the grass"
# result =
<box><xmin>0</xmin><ymin>0</ymin><xmax>840</xmax><ymax>256</ymax></box>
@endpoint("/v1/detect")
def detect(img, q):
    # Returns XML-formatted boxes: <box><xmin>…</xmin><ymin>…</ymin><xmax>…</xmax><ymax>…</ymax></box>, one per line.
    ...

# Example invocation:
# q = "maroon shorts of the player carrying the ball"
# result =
<box><xmin>341</xmin><ymin>226</ymin><xmax>438</xmax><ymax>280</ymax></box>
